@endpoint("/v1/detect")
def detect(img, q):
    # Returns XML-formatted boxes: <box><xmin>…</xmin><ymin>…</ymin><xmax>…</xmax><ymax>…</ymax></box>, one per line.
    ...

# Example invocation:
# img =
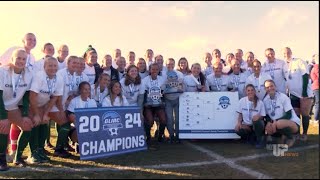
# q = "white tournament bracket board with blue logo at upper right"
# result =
<box><xmin>179</xmin><ymin>92</ymin><xmax>240</xmax><ymax>139</ymax></box>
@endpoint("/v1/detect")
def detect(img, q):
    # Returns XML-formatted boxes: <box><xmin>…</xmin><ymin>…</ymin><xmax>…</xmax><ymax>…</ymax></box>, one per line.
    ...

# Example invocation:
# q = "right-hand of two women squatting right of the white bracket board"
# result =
<box><xmin>263</xmin><ymin>80</ymin><xmax>300</xmax><ymax>147</ymax></box>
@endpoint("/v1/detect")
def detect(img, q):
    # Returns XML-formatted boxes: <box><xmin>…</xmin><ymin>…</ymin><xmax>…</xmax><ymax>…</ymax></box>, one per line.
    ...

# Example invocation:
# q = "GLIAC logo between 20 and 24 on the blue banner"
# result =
<box><xmin>102</xmin><ymin>111</ymin><xmax>123</xmax><ymax>136</ymax></box>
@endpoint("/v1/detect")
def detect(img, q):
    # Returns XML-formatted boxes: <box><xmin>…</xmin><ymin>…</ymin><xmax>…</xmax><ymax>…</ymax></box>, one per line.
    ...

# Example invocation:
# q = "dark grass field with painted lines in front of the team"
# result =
<box><xmin>0</xmin><ymin>124</ymin><xmax>319</xmax><ymax>179</ymax></box>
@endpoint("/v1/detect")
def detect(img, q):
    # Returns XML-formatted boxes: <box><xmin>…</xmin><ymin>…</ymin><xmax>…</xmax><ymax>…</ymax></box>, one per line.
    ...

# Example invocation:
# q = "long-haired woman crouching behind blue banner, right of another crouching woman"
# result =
<box><xmin>102</xmin><ymin>81</ymin><xmax>129</xmax><ymax>107</ymax></box>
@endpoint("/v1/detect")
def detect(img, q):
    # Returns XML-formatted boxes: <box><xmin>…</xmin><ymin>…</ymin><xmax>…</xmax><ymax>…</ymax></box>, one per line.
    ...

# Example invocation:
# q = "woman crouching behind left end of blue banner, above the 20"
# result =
<box><xmin>66</xmin><ymin>81</ymin><xmax>97</xmax><ymax>147</ymax></box>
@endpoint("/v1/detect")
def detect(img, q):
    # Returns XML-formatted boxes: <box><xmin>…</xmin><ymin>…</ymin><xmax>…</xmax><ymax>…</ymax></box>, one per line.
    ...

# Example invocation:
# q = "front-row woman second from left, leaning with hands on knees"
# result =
<box><xmin>27</xmin><ymin>57</ymin><xmax>64</xmax><ymax>164</ymax></box>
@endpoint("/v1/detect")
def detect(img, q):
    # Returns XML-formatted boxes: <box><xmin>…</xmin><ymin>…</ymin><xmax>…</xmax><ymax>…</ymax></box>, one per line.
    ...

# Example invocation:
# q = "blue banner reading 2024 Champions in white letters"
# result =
<box><xmin>75</xmin><ymin>106</ymin><xmax>147</xmax><ymax>160</ymax></box>
